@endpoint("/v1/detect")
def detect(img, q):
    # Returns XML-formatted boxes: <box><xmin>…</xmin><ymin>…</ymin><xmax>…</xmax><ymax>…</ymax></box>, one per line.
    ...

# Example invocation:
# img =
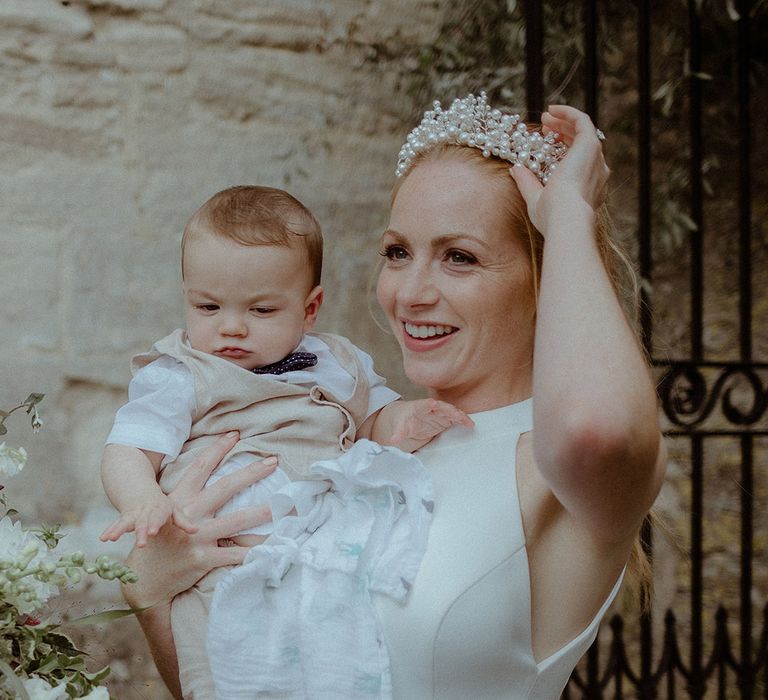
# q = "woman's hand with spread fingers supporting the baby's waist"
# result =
<box><xmin>123</xmin><ymin>433</ymin><xmax>277</xmax><ymax>608</ymax></box>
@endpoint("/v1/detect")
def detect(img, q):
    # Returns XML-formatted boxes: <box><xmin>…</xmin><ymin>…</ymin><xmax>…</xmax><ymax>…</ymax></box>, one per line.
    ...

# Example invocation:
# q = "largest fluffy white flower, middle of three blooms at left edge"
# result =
<box><xmin>0</xmin><ymin>516</ymin><xmax>59</xmax><ymax>613</ymax></box>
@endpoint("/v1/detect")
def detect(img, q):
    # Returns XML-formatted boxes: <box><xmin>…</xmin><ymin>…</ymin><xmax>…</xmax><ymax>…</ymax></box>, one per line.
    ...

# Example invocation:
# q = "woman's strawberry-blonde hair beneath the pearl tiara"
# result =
<box><xmin>391</xmin><ymin>144</ymin><xmax>658</xmax><ymax>609</ymax></box>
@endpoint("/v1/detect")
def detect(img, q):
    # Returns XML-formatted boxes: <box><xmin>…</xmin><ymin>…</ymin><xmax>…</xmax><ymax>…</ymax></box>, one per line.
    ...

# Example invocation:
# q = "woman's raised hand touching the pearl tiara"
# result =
<box><xmin>509</xmin><ymin>105</ymin><xmax>610</xmax><ymax>238</ymax></box>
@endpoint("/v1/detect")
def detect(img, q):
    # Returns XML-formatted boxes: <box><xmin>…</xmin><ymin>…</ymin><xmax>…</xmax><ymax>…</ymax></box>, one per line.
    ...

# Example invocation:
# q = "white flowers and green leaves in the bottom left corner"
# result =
<box><xmin>0</xmin><ymin>394</ymin><xmax>136</xmax><ymax>700</ymax></box>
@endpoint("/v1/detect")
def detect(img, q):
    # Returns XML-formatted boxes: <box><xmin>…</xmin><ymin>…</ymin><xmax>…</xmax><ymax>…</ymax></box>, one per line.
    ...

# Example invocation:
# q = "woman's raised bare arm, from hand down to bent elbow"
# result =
<box><xmin>512</xmin><ymin>106</ymin><xmax>666</xmax><ymax>541</ymax></box>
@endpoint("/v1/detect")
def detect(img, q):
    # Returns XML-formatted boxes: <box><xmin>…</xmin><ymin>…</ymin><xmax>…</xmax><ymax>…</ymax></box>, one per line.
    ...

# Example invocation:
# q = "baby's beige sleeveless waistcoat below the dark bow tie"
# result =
<box><xmin>132</xmin><ymin>330</ymin><xmax>376</xmax><ymax>486</ymax></box>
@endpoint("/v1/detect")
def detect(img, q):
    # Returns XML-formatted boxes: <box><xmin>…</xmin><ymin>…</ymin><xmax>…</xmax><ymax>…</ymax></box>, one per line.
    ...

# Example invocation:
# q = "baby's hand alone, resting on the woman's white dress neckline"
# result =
<box><xmin>390</xmin><ymin>399</ymin><xmax>475</xmax><ymax>452</ymax></box>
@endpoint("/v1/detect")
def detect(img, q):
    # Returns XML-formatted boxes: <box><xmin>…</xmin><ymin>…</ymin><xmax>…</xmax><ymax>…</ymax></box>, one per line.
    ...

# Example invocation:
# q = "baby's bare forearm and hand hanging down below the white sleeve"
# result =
<box><xmin>101</xmin><ymin>445</ymin><xmax>195</xmax><ymax>547</ymax></box>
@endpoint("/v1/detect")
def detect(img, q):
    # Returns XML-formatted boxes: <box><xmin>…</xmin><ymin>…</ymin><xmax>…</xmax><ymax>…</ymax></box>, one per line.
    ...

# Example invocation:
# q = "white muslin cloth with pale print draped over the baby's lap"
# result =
<box><xmin>207</xmin><ymin>440</ymin><xmax>433</xmax><ymax>700</ymax></box>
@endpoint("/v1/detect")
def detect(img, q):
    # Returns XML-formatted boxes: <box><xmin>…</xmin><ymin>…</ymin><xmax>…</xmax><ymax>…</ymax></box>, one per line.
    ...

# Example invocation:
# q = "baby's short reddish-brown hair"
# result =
<box><xmin>181</xmin><ymin>185</ymin><xmax>323</xmax><ymax>287</ymax></box>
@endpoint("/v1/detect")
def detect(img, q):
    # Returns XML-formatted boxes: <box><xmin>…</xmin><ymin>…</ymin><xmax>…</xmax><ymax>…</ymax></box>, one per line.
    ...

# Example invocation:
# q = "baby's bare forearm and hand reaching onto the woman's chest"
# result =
<box><xmin>358</xmin><ymin>399</ymin><xmax>474</xmax><ymax>452</ymax></box>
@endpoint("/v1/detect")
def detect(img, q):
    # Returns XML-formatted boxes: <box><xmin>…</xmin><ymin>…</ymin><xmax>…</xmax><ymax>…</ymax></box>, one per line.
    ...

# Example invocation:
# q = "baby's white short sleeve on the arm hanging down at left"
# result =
<box><xmin>106</xmin><ymin>355</ymin><xmax>195</xmax><ymax>459</ymax></box>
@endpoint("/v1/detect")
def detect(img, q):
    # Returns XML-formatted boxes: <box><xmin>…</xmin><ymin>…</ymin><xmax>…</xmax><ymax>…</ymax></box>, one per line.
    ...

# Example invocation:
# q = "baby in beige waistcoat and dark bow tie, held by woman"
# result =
<box><xmin>101</xmin><ymin>186</ymin><xmax>464</xmax><ymax>547</ymax></box>
